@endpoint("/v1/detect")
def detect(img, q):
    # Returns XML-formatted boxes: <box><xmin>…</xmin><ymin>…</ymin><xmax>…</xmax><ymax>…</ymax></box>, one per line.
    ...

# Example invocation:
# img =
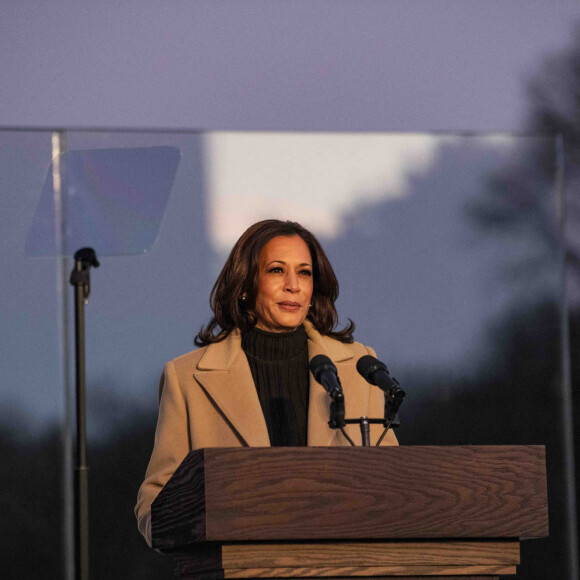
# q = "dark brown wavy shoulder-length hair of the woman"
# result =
<box><xmin>194</xmin><ymin>220</ymin><xmax>354</xmax><ymax>346</ymax></box>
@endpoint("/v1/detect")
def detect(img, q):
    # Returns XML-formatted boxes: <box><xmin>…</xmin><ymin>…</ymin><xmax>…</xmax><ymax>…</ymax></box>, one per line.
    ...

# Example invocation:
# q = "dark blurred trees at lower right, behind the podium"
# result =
<box><xmin>400</xmin><ymin>302</ymin><xmax>567</xmax><ymax>580</ymax></box>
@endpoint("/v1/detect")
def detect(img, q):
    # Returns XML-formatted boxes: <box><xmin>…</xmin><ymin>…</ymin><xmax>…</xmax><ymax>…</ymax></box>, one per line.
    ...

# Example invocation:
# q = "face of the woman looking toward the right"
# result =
<box><xmin>256</xmin><ymin>236</ymin><xmax>313</xmax><ymax>332</ymax></box>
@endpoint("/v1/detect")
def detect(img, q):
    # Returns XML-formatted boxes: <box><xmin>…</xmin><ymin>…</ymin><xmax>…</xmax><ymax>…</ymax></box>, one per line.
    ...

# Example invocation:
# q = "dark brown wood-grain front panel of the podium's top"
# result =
<box><xmin>205</xmin><ymin>446</ymin><xmax>548</xmax><ymax>541</ymax></box>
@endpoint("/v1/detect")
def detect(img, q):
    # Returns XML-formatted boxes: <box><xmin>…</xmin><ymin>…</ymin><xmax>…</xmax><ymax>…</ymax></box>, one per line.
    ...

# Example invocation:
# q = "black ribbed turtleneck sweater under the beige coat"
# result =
<box><xmin>242</xmin><ymin>326</ymin><xmax>309</xmax><ymax>447</ymax></box>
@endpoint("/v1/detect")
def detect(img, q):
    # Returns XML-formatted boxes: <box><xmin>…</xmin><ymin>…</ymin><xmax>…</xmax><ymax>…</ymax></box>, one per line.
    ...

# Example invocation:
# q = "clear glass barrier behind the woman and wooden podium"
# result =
<box><xmin>0</xmin><ymin>132</ymin><xmax>564</xmax><ymax>578</ymax></box>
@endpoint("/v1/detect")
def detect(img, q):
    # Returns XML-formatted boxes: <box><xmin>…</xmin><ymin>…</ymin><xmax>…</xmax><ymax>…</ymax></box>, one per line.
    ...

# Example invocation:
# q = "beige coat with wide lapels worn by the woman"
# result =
<box><xmin>135</xmin><ymin>321</ymin><xmax>397</xmax><ymax>545</ymax></box>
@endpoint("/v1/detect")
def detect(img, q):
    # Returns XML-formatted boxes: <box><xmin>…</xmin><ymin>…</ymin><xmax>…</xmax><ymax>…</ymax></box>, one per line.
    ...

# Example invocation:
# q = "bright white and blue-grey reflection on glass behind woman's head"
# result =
<box><xmin>208</xmin><ymin>133</ymin><xmax>559</xmax><ymax>372</ymax></box>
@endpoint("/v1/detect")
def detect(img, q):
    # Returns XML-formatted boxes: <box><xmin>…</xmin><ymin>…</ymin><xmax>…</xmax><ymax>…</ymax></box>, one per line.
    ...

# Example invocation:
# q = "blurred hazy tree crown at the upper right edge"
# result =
<box><xmin>470</xmin><ymin>26</ymin><xmax>580</xmax><ymax>291</ymax></box>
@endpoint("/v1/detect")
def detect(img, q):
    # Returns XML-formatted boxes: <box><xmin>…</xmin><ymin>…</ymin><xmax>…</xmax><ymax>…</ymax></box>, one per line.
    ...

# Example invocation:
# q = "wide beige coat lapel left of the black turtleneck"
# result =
<box><xmin>194</xmin><ymin>331</ymin><xmax>270</xmax><ymax>447</ymax></box>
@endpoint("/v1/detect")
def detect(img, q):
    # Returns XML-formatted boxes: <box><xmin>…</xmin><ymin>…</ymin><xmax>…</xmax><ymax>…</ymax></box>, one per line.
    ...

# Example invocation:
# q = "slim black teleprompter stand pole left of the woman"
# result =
<box><xmin>70</xmin><ymin>248</ymin><xmax>99</xmax><ymax>580</ymax></box>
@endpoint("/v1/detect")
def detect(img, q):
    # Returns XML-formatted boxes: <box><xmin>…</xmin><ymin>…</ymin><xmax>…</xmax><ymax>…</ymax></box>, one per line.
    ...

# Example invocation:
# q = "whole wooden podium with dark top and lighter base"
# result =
<box><xmin>151</xmin><ymin>446</ymin><xmax>548</xmax><ymax>580</ymax></box>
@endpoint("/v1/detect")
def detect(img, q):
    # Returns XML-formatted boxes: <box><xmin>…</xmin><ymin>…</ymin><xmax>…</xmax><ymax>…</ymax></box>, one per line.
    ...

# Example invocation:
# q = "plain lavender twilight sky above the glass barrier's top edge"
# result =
<box><xmin>0</xmin><ymin>0</ymin><xmax>580</xmax><ymax>131</ymax></box>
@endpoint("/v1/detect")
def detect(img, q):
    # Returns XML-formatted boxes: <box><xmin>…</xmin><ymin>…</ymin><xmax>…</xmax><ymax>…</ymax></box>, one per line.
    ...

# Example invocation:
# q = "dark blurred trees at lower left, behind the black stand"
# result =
<box><xmin>0</xmin><ymin>390</ymin><xmax>174</xmax><ymax>580</ymax></box>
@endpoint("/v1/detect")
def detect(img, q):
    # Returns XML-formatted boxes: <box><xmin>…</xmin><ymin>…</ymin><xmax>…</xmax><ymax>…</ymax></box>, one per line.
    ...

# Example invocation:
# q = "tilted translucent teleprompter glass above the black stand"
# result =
<box><xmin>26</xmin><ymin>146</ymin><xmax>180</xmax><ymax>256</ymax></box>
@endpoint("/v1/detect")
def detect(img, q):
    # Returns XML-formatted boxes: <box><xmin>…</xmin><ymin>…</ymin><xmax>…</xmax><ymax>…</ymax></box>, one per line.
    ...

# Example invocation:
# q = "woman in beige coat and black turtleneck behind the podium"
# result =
<box><xmin>135</xmin><ymin>220</ymin><xmax>397</xmax><ymax>545</ymax></box>
